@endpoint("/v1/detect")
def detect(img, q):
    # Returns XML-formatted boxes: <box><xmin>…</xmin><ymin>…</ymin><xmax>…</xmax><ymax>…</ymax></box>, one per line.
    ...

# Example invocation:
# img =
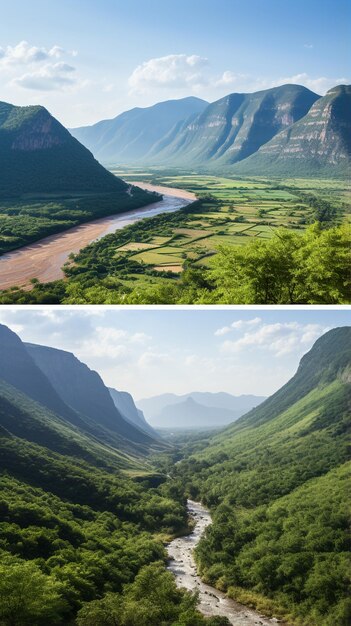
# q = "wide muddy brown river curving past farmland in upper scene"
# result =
<box><xmin>0</xmin><ymin>182</ymin><xmax>196</xmax><ymax>289</ymax></box>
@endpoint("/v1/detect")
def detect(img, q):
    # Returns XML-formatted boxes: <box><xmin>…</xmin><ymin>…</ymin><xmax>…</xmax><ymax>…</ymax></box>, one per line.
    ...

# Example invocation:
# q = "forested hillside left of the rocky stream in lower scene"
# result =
<box><xmin>0</xmin><ymin>326</ymin><xmax>227</xmax><ymax>626</ymax></box>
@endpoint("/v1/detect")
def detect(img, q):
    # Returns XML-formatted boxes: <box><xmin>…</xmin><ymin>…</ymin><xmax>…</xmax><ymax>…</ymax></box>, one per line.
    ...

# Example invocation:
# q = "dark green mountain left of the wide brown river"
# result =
<box><xmin>0</xmin><ymin>102</ymin><xmax>126</xmax><ymax>197</ymax></box>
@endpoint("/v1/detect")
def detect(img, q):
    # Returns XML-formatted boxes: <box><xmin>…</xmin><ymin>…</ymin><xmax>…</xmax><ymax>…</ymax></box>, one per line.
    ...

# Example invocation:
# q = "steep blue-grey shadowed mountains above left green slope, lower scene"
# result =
<box><xmin>0</xmin><ymin>325</ymin><xmax>164</xmax><ymax>466</ymax></box>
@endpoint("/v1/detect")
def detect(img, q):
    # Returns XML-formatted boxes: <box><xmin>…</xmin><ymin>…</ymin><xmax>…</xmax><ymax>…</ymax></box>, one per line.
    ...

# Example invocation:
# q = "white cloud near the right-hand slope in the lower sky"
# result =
<box><xmin>221</xmin><ymin>322</ymin><xmax>329</xmax><ymax>357</ymax></box>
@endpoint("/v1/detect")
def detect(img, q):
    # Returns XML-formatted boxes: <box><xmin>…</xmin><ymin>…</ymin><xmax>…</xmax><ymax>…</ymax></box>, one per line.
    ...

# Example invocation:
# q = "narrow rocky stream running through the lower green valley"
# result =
<box><xmin>167</xmin><ymin>500</ymin><xmax>282</xmax><ymax>626</ymax></box>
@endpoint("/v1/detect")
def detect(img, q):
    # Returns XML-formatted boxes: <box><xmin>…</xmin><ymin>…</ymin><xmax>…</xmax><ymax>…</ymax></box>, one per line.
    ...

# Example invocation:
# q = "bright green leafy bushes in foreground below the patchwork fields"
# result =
<box><xmin>209</xmin><ymin>225</ymin><xmax>351</xmax><ymax>304</ymax></box>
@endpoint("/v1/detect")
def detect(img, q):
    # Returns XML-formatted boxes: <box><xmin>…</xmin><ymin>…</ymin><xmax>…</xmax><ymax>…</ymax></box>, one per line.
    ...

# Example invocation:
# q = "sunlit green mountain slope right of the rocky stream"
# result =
<box><xmin>176</xmin><ymin>327</ymin><xmax>351</xmax><ymax>626</ymax></box>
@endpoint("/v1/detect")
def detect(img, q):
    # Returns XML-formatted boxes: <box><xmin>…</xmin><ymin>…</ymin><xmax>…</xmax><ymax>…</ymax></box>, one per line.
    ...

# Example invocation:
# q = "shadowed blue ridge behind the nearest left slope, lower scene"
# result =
<box><xmin>25</xmin><ymin>343</ymin><xmax>158</xmax><ymax>444</ymax></box>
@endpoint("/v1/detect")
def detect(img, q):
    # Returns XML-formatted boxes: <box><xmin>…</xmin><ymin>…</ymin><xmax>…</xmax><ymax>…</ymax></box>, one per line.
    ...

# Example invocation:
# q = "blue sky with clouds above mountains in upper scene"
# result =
<box><xmin>0</xmin><ymin>0</ymin><xmax>351</xmax><ymax>127</ymax></box>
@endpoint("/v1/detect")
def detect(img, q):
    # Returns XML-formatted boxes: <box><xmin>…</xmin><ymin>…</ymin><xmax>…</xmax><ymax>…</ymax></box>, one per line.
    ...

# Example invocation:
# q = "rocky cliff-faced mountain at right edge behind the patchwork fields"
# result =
<box><xmin>233</xmin><ymin>85</ymin><xmax>351</xmax><ymax>176</ymax></box>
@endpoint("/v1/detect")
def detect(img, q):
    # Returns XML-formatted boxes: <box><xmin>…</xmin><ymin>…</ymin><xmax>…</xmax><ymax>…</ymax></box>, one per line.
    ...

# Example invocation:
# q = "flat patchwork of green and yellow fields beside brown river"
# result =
<box><xmin>109</xmin><ymin>168</ymin><xmax>350</xmax><ymax>273</ymax></box>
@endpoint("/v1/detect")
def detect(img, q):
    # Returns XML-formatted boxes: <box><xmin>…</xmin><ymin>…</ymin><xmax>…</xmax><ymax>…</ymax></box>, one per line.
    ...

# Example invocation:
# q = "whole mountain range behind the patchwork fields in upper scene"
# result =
<box><xmin>71</xmin><ymin>84</ymin><xmax>351</xmax><ymax>176</ymax></box>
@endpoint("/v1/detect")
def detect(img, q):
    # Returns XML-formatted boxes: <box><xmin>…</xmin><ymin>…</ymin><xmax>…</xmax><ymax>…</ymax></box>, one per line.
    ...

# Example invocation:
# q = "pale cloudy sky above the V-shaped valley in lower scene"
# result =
<box><xmin>0</xmin><ymin>306</ymin><xmax>351</xmax><ymax>400</ymax></box>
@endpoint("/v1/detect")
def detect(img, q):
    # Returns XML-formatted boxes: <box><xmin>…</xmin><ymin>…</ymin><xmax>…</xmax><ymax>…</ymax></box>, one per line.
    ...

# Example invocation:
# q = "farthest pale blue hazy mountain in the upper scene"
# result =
<box><xmin>70</xmin><ymin>97</ymin><xmax>208</xmax><ymax>163</ymax></box>
